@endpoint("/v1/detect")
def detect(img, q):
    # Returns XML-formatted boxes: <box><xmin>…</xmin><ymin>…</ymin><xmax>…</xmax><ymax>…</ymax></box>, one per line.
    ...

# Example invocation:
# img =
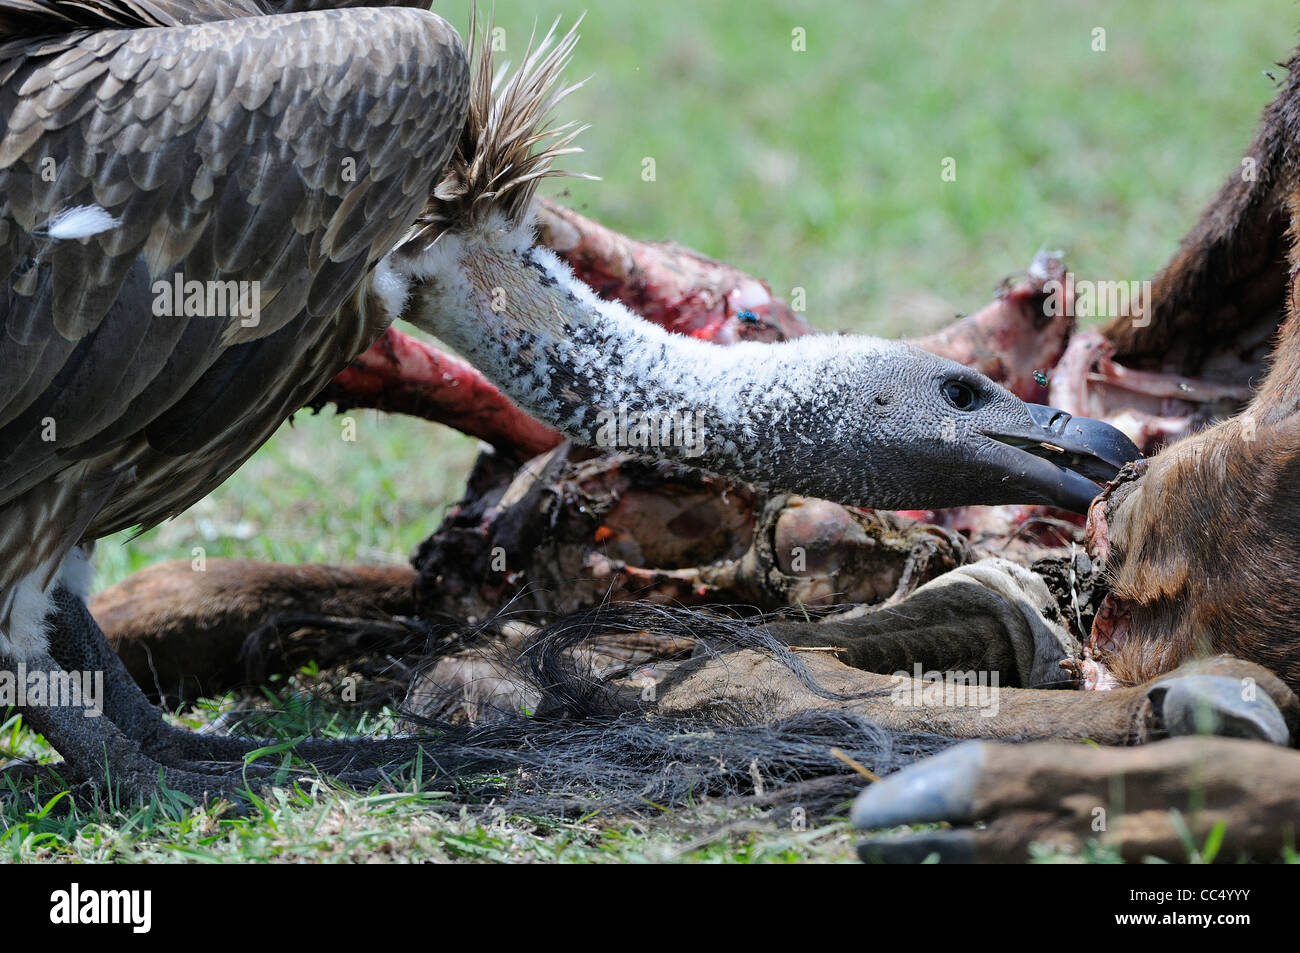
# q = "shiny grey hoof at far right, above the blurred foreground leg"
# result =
<box><xmin>1147</xmin><ymin>675</ymin><xmax>1291</xmax><ymax>745</ymax></box>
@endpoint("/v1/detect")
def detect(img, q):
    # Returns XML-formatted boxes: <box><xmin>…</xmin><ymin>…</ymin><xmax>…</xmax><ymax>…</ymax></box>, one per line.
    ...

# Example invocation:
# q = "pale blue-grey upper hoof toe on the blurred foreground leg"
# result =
<box><xmin>852</xmin><ymin>741</ymin><xmax>985</xmax><ymax>829</ymax></box>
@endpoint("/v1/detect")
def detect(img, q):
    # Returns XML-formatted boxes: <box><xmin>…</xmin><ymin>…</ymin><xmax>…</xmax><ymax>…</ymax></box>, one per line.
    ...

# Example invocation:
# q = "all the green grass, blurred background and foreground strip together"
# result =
<box><xmin>0</xmin><ymin>0</ymin><xmax>1297</xmax><ymax>862</ymax></box>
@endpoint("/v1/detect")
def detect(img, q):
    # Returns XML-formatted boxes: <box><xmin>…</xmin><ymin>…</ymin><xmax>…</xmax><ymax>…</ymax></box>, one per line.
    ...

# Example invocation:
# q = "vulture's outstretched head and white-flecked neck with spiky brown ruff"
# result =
<box><xmin>384</xmin><ymin>18</ymin><xmax>1139</xmax><ymax>512</ymax></box>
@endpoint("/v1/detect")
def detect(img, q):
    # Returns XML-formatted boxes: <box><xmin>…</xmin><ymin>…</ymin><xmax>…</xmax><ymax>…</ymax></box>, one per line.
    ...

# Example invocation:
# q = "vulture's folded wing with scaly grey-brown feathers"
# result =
<box><xmin>0</xmin><ymin>0</ymin><xmax>468</xmax><ymax>598</ymax></box>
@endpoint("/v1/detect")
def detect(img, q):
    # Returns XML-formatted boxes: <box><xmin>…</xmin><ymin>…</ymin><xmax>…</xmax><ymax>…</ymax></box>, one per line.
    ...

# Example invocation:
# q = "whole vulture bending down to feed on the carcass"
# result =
<box><xmin>0</xmin><ymin>0</ymin><xmax>1136</xmax><ymax>798</ymax></box>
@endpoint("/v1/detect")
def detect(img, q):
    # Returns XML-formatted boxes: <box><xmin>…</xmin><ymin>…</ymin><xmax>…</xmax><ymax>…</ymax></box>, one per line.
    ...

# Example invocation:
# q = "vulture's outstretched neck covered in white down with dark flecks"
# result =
<box><xmin>390</xmin><ymin>216</ymin><xmax>905</xmax><ymax>503</ymax></box>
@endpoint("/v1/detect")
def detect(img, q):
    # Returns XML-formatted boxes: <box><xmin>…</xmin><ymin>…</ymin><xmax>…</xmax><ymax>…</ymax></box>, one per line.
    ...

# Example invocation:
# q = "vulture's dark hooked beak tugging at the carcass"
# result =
<box><xmin>983</xmin><ymin>404</ymin><xmax>1141</xmax><ymax>514</ymax></box>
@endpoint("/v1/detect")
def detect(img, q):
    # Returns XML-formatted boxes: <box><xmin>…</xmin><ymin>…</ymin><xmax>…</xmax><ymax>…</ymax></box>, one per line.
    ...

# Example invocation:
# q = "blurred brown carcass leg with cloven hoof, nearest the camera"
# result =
<box><xmin>853</xmin><ymin>737</ymin><xmax>1300</xmax><ymax>863</ymax></box>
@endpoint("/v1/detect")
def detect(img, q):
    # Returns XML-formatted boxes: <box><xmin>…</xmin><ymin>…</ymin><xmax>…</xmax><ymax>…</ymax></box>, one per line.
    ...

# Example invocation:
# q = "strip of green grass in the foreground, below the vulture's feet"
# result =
<box><xmin>0</xmin><ymin>785</ymin><xmax>868</xmax><ymax>863</ymax></box>
